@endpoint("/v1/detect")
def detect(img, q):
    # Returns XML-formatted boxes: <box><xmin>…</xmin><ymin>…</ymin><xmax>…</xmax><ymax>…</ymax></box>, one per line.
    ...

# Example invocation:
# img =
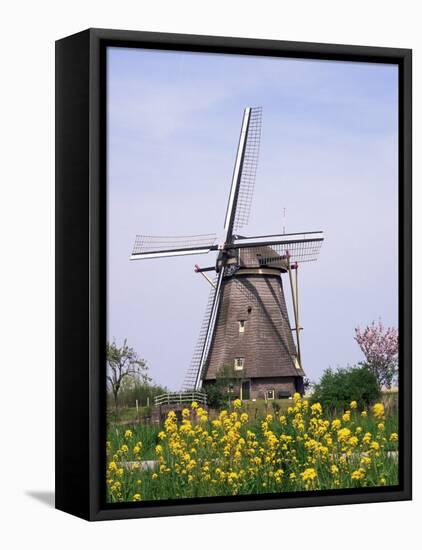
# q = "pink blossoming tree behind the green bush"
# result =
<box><xmin>355</xmin><ymin>321</ymin><xmax>399</xmax><ymax>388</ymax></box>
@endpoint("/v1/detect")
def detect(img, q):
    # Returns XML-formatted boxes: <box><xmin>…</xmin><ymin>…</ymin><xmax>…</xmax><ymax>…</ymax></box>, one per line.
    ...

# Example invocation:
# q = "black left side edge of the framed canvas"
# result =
<box><xmin>55</xmin><ymin>31</ymin><xmax>92</xmax><ymax>519</ymax></box>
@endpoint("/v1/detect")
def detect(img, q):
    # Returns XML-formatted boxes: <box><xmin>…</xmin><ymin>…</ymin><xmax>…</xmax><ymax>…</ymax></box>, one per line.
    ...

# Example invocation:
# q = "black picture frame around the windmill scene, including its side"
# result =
<box><xmin>56</xmin><ymin>29</ymin><xmax>412</xmax><ymax>520</ymax></box>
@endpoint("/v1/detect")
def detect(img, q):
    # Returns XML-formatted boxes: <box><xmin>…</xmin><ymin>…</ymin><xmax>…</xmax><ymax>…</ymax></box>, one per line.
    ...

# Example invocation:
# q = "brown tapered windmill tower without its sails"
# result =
<box><xmin>202</xmin><ymin>250</ymin><xmax>304</xmax><ymax>399</ymax></box>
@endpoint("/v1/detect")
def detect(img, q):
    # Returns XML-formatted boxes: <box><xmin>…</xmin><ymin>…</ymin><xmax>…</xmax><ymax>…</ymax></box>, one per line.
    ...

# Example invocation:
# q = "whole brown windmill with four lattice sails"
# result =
<box><xmin>130</xmin><ymin>107</ymin><xmax>324</xmax><ymax>399</ymax></box>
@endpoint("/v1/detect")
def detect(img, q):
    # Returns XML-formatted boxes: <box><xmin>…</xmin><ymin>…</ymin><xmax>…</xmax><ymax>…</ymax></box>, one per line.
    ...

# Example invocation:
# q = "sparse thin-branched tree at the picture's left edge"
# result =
<box><xmin>107</xmin><ymin>339</ymin><xmax>151</xmax><ymax>416</ymax></box>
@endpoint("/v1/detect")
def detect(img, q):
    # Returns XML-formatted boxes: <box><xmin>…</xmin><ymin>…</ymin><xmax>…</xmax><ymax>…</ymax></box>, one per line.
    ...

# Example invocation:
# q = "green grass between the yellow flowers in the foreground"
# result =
<box><xmin>107</xmin><ymin>396</ymin><xmax>398</xmax><ymax>502</ymax></box>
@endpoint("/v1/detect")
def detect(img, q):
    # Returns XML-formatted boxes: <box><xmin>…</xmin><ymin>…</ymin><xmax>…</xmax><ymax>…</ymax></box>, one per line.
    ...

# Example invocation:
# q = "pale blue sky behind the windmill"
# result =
<box><xmin>108</xmin><ymin>48</ymin><xmax>398</xmax><ymax>389</ymax></box>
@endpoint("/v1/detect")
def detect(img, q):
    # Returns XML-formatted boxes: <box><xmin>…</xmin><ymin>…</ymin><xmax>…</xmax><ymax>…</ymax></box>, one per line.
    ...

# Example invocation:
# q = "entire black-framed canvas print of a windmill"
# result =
<box><xmin>56</xmin><ymin>29</ymin><xmax>411</xmax><ymax>520</ymax></box>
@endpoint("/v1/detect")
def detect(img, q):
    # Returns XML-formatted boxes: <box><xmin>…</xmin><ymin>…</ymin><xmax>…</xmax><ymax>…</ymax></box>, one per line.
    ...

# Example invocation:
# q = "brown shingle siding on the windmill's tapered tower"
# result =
<box><xmin>203</xmin><ymin>269</ymin><xmax>304</xmax><ymax>389</ymax></box>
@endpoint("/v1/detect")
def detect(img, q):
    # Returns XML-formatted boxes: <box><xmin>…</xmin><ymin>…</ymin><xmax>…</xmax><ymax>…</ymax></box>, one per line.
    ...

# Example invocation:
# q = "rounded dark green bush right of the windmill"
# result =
<box><xmin>310</xmin><ymin>364</ymin><xmax>380</xmax><ymax>412</ymax></box>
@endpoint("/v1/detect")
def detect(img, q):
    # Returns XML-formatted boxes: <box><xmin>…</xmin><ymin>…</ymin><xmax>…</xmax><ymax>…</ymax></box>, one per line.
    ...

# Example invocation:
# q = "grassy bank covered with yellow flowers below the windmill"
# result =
<box><xmin>107</xmin><ymin>399</ymin><xmax>398</xmax><ymax>502</ymax></box>
